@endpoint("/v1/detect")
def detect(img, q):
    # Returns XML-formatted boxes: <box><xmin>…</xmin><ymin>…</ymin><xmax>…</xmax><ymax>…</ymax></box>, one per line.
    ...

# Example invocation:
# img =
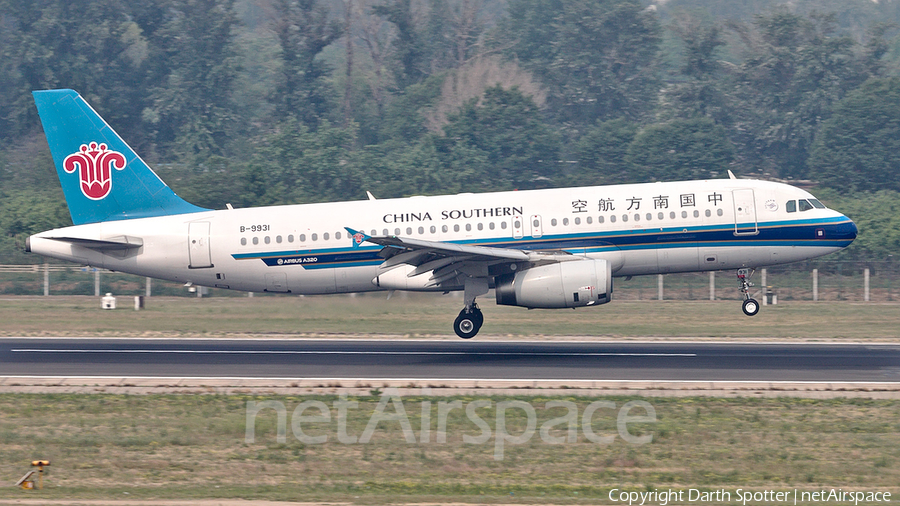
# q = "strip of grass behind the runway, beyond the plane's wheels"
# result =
<box><xmin>0</xmin><ymin>294</ymin><xmax>900</xmax><ymax>341</ymax></box>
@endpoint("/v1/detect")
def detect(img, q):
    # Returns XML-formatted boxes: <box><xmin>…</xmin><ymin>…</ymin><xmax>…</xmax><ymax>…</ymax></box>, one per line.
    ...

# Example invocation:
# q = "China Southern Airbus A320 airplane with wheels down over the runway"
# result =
<box><xmin>26</xmin><ymin>90</ymin><xmax>857</xmax><ymax>339</ymax></box>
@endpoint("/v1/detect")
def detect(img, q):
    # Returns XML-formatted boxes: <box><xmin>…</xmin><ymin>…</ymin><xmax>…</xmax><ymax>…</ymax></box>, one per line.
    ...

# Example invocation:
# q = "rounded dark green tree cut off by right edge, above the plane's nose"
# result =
<box><xmin>809</xmin><ymin>77</ymin><xmax>900</xmax><ymax>192</ymax></box>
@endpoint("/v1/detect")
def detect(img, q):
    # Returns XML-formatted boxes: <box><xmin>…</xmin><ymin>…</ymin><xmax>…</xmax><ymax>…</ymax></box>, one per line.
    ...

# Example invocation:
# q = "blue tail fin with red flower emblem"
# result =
<box><xmin>32</xmin><ymin>90</ymin><xmax>206</xmax><ymax>225</ymax></box>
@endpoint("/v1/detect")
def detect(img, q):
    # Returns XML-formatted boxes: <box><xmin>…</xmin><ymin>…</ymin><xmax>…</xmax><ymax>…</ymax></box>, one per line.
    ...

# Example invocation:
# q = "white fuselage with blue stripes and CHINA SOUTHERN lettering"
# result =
<box><xmin>30</xmin><ymin>179</ymin><xmax>856</xmax><ymax>294</ymax></box>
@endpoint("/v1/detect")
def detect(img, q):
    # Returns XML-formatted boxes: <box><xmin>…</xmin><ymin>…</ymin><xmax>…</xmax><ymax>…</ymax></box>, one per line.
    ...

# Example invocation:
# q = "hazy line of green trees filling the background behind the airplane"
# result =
<box><xmin>0</xmin><ymin>0</ymin><xmax>900</xmax><ymax>258</ymax></box>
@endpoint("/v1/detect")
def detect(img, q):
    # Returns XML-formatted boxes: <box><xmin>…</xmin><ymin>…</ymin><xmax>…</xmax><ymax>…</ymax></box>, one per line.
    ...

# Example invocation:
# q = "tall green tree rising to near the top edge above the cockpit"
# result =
<box><xmin>732</xmin><ymin>8</ymin><xmax>880</xmax><ymax>177</ymax></box>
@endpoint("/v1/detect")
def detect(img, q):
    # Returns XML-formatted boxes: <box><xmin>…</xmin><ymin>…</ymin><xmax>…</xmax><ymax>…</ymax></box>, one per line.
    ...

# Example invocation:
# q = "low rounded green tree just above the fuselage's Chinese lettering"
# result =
<box><xmin>626</xmin><ymin>118</ymin><xmax>734</xmax><ymax>182</ymax></box>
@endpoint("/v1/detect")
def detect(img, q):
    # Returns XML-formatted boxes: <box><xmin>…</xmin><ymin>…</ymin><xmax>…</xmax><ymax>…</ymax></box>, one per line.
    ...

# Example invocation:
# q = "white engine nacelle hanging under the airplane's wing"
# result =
<box><xmin>495</xmin><ymin>259</ymin><xmax>612</xmax><ymax>309</ymax></box>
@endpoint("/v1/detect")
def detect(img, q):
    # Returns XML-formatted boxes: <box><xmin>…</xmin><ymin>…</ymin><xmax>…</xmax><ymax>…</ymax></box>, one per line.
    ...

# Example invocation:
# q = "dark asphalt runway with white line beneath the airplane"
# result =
<box><xmin>0</xmin><ymin>338</ymin><xmax>900</xmax><ymax>382</ymax></box>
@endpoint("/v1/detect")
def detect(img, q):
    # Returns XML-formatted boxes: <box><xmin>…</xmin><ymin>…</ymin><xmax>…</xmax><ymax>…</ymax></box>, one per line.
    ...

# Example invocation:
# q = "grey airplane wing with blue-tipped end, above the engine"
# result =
<box><xmin>344</xmin><ymin>227</ymin><xmax>572</xmax><ymax>286</ymax></box>
